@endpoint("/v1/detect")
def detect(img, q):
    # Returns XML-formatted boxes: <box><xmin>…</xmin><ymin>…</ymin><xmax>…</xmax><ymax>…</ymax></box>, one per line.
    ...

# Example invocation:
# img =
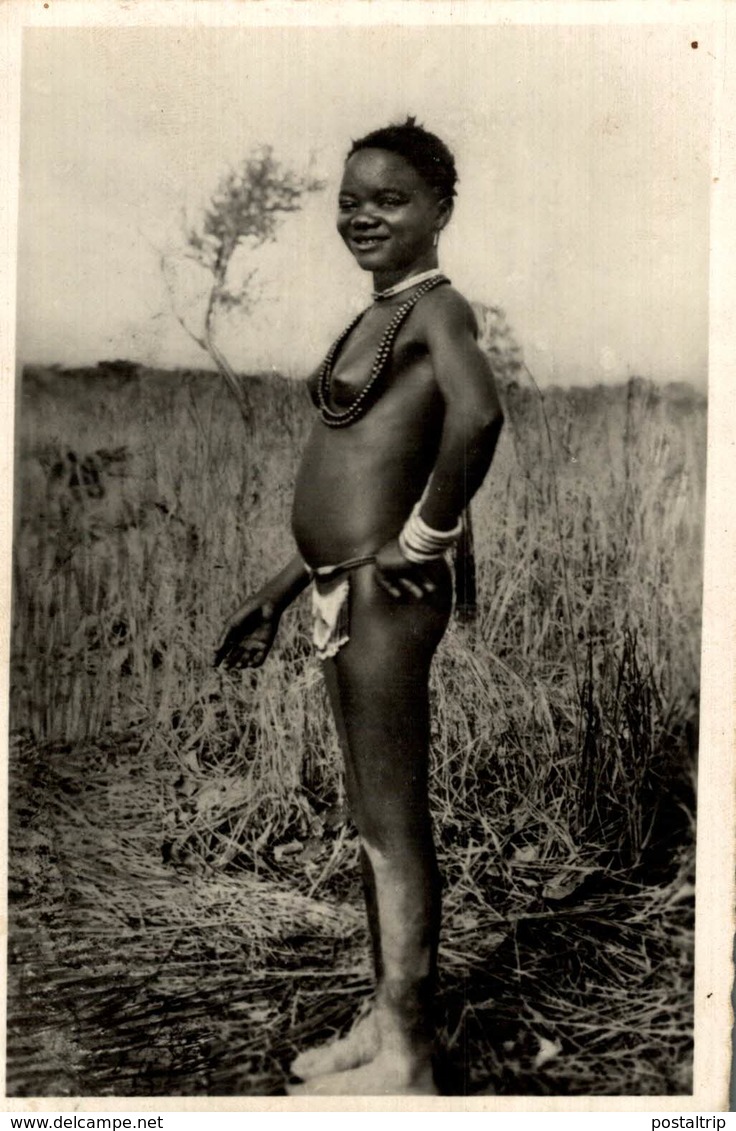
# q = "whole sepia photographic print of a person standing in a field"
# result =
<box><xmin>6</xmin><ymin>8</ymin><xmax>716</xmax><ymax>1103</ymax></box>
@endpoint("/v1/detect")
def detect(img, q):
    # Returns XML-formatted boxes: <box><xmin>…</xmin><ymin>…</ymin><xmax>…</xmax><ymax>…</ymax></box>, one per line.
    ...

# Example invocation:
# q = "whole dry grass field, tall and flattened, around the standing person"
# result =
<box><xmin>8</xmin><ymin>366</ymin><xmax>705</xmax><ymax>1096</ymax></box>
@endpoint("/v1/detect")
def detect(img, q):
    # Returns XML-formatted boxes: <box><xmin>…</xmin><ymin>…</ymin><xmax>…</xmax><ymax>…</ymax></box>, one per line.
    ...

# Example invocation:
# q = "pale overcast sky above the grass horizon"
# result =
<box><xmin>18</xmin><ymin>23</ymin><xmax>712</xmax><ymax>386</ymax></box>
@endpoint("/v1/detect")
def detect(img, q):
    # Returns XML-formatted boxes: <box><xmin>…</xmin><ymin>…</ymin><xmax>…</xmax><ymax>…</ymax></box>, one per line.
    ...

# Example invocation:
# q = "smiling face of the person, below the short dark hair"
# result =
<box><xmin>337</xmin><ymin>149</ymin><xmax>451</xmax><ymax>279</ymax></box>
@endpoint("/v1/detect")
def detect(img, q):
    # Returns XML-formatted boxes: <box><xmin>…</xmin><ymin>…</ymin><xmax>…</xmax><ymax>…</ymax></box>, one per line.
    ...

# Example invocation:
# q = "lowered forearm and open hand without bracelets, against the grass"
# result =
<box><xmin>215</xmin><ymin>554</ymin><xmax>311</xmax><ymax>667</ymax></box>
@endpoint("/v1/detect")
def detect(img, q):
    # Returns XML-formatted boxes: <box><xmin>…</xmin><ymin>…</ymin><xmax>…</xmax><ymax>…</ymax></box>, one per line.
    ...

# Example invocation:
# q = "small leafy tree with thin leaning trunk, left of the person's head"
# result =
<box><xmin>161</xmin><ymin>146</ymin><xmax>323</xmax><ymax>424</ymax></box>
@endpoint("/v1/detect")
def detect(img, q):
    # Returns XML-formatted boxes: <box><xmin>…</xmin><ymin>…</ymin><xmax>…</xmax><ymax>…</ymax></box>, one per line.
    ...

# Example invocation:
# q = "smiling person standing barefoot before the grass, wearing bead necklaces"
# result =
<box><xmin>216</xmin><ymin>119</ymin><xmax>502</xmax><ymax>1095</ymax></box>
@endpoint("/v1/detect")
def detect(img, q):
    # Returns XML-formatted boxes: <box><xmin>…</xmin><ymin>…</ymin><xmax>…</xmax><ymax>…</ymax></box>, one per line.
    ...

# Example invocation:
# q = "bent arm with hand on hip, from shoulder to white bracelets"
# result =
<box><xmin>419</xmin><ymin>288</ymin><xmax>503</xmax><ymax>530</ymax></box>
